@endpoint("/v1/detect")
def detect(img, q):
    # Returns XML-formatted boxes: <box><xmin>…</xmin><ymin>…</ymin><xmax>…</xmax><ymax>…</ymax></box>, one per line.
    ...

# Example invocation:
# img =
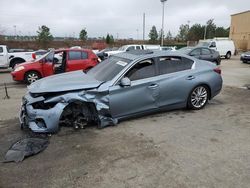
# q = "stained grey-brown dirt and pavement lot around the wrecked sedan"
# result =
<box><xmin>0</xmin><ymin>57</ymin><xmax>250</xmax><ymax>188</ymax></box>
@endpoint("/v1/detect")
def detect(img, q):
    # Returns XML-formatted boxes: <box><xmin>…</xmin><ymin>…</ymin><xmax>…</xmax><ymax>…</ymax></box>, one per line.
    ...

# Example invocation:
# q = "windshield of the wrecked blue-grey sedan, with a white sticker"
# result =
<box><xmin>87</xmin><ymin>56</ymin><xmax>131</xmax><ymax>81</ymax></box>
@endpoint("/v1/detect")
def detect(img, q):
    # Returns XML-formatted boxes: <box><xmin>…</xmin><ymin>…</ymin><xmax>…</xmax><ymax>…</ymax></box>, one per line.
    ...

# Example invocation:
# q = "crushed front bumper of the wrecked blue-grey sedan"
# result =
<box><xmin>19</xmin><ymin>94</ymin><xmax>66</xmax><ymax>133</ymax></box>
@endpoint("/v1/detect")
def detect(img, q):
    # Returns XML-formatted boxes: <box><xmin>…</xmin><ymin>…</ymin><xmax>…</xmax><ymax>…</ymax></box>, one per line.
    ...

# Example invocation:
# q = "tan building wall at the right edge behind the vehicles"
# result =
<box><xmin>229</xmin><ymin>10</ymin><xmax>250</xmax><ymax>50</ymax></box>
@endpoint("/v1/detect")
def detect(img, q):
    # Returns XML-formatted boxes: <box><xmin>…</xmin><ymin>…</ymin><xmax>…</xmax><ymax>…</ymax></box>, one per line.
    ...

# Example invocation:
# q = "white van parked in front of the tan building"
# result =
<box><xmin>198</xmin><ymin>38</ymin><xmax>235</xmax><ymax>59</ymax></box>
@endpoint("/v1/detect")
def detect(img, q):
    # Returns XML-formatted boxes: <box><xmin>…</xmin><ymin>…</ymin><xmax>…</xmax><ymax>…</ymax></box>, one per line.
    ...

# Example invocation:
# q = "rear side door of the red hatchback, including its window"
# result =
<box><xmin>65</xmin><ymin>50</ymin><xmax>89</xmax><ymax>72</ymax></box>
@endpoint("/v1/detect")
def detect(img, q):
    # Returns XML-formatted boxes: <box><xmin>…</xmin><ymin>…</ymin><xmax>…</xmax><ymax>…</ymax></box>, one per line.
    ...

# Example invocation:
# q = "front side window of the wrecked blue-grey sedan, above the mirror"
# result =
<box><xmin>125</xmin><ymin>59</ymin><xmax>156</xmax><ymax>81</ymax></box>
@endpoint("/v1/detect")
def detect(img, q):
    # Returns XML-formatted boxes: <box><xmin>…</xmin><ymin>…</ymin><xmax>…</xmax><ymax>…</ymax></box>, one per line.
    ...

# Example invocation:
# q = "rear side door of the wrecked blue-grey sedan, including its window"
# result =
<box><xmin>157</xmin><ymin>56</ymin><xmax>196</xmax><ymax>108</ymax></box>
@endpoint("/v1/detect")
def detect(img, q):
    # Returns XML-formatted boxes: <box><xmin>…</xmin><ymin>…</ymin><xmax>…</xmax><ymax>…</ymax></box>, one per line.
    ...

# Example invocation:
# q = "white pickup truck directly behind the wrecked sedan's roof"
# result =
<box><xmin>104</xmin><ymin>44</ymin><xmax>160</xmax><ymax>57</ymax></box>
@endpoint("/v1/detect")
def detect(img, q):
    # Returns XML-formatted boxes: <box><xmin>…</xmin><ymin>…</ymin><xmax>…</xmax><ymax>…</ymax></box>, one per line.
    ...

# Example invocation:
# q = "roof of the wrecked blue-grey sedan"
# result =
<box><xmin>112</xmin><ymin>50</ymin><xmax>194</xmax><ymax>61</ymax></box>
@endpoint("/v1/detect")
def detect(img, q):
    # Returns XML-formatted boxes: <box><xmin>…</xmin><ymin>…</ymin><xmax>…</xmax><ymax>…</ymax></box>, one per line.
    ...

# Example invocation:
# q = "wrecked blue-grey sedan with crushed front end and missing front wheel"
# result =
<box><xmin>20</xmin><ymin>51</ymin><xmax>222</xmax><ymax>132</ymax></box>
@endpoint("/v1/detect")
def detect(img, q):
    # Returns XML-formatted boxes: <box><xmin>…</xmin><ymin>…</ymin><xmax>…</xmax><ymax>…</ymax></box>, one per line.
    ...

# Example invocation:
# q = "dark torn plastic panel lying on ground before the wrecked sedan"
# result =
<box><xmin>3</xmin><ymin>138</ymin><xmax>49</xmax><ymax>162</ymax></box>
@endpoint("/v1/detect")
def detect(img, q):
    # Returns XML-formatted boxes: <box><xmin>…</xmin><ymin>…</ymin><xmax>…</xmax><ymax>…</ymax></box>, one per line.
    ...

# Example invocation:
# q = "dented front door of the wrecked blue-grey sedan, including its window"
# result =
<box><xmin>109</xmin><ymin>59</ymin><xmax>159</xmax><ymax>118</ymax></box>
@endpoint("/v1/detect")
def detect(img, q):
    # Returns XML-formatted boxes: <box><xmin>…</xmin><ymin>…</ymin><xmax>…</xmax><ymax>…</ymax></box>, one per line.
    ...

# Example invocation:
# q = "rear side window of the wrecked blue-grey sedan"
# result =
<box><xmin>158</xmin><ymin>57</ymin><xmax>194</xmax><ymax>75</ymax></box>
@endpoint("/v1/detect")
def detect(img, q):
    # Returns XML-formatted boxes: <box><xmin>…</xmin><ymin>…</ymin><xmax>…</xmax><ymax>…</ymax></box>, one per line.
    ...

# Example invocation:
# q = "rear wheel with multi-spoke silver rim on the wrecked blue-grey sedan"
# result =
<box><xmin>188</xmin><ymin>85</ymin><xmax>209</xmax><ymax>110</ymax></box>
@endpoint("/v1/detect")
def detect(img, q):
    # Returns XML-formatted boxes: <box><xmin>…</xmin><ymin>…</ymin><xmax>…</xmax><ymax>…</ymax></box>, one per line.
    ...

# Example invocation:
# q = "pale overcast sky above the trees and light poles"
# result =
<box><xmin>0</xmin><ymin>0</ymin><xmax>250</xmax><ymax>39</ymax></box>
